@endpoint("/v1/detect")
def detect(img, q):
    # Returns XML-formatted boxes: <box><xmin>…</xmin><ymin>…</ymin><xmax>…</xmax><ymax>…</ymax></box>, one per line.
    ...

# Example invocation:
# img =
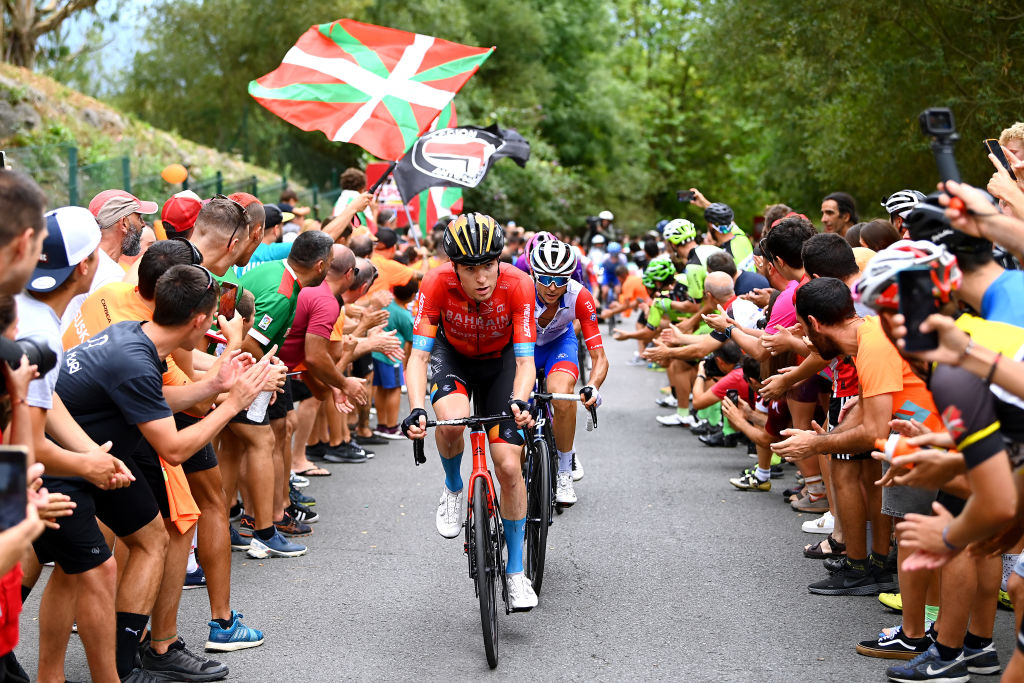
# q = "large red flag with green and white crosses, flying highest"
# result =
<box><xmin>249</xmin><ymin>19</ymin><xmax>495</xmax><ymax>161</ymax></box>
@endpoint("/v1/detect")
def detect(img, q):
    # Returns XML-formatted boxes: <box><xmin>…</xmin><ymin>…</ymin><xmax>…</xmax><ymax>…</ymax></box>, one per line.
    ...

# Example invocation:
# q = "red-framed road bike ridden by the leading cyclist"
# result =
<box><xmin>413</xmin><ymin>407</ymin><xmax>510</xmax><ymax>669</ymax></box>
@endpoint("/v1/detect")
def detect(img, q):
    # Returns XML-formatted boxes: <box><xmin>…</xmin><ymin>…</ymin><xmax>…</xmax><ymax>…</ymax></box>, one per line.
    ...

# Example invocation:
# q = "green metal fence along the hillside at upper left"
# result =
<box><xmin>5</xmin><ymin>144</ymin><xmax>341</xmax><ymax>218</ymax></box>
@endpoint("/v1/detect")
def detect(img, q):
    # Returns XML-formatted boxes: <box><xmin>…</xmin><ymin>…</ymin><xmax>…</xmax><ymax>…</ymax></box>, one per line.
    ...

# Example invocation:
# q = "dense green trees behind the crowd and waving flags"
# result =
<box><xmin>103</xmin><ymin>0</ymin><xmax>1024</xmax><ymax>232</ymax></box>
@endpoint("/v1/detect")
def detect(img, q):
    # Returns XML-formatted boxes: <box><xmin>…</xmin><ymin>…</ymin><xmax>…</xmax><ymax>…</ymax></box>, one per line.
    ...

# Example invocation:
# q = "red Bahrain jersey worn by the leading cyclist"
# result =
<box><xmin>413</xmin><ymin>263</ymin><xmax>537</xmax><ymax>358</ymax></box>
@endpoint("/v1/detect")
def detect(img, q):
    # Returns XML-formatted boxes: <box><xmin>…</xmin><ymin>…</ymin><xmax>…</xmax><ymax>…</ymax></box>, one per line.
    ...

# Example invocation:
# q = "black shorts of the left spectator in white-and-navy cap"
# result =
<box><xmin>32</xmin><ymin>477</ymin><xmax>111</xmax><ymax>574</ymax></box>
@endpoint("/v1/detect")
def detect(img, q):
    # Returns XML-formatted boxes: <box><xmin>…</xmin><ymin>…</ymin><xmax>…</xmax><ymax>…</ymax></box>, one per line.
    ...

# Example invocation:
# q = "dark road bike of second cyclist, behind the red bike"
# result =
<box><xmin>522</xmin><ymin>377</ymin><xmax>597</xmax><ymax>595</ymax></box>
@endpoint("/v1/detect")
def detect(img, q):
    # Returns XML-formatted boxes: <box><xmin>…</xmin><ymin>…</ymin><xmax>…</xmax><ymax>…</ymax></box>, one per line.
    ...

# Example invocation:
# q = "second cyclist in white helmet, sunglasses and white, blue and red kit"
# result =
<box><xmin>529</xmin><ymin>240</ymin><xmax>608</xmax><ymax>506</ymax></box>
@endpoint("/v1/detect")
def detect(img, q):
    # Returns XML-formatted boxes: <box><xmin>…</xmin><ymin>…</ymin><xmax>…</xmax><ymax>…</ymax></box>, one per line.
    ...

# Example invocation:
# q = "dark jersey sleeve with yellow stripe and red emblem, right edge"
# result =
<box><xmin>928</xmin><ymin>366</ymin><xmax>1024</xmax><ymax>470</ymax></box>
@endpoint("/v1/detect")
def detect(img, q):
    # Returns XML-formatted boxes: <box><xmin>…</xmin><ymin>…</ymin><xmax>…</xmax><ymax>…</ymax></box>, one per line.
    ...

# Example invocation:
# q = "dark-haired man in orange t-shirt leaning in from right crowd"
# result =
<box><xmin>772</xmin><ymin>278</ymin><xmax>944</xmax><ymax>656</ymax></box>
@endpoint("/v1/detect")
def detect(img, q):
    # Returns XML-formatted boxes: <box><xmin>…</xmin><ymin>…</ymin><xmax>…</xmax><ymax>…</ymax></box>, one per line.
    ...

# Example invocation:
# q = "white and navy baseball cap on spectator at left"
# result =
<box><xmin>26</xmin><ymin>206</ymin><xmax>102</xmax><ymax>292</ymax></box>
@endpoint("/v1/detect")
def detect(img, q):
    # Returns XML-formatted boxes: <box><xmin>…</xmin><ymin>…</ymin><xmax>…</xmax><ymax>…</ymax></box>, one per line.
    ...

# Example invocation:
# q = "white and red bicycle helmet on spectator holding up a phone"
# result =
<box><xmin>854</xmin><ymin>240</ymin><xmax>963</xmax><ymax>310</ymax></box>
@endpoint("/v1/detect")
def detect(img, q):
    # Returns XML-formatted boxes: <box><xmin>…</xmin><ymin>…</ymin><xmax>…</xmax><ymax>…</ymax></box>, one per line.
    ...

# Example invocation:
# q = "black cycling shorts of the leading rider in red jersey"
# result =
<box><xmin>430</xmin><ymin>334</ymin><xmax>525</xmax><ymax>445</ymax></box>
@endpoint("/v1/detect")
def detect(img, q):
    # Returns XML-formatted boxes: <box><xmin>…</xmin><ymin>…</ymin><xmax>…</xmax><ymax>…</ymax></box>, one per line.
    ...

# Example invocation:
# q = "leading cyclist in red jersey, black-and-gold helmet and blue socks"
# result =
<box><xmin>401</xmin><ymin>213</ymin><xmax>538</xmax><ymax>611</ymax></box>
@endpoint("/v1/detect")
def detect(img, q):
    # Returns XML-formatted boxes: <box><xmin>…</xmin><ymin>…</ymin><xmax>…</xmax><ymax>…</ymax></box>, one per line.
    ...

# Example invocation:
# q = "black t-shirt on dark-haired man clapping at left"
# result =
<box><xmin>56</xmin><ymin>322</ymin><xmax>172</xmax><ymax>460</ymax></box>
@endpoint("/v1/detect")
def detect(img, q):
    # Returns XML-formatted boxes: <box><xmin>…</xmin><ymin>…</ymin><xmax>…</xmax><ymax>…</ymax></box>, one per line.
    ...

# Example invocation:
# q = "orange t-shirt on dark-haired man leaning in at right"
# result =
<box><xmin>853</xmin><ymin>315</ymin><xmax>944</xmax><ymax>431</ymax></box>
